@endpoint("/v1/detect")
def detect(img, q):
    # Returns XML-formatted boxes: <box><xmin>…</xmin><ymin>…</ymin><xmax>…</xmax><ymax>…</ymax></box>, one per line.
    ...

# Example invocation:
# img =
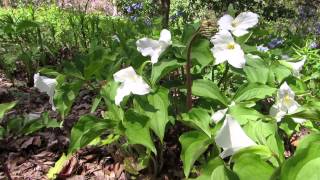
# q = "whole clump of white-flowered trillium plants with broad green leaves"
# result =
<box><xmin>23</xmin><ymin>12</ymin><xmax>320</xmax><ymax>180</ymax></box>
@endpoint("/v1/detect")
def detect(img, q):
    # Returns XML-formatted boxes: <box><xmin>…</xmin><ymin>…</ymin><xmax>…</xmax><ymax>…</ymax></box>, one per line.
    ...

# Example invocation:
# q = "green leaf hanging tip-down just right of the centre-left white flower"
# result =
<box><xmin>137</xmin><ymin>87</ymin><xmax>169</xmax><ymax>142</ymax></box>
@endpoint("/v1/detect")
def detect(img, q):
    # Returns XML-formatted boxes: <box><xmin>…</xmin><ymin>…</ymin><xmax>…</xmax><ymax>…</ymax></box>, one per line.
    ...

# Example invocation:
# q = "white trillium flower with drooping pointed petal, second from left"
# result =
<box><xmin>113</xmin><ymin>66</ymin><xmax>150</xmax><ymax>105</ymax></box>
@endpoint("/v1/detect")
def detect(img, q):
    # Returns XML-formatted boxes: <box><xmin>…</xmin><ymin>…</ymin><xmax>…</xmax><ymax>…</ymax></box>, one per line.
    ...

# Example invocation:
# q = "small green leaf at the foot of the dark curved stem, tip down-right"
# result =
<box><xmin>182</xmin><ymin>108</ymin><xmax>211</xmax><ymax>138</ymax></box>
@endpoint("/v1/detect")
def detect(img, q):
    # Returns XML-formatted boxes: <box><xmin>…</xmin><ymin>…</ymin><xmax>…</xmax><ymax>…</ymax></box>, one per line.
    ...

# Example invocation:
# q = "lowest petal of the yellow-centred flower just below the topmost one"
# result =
<box><xmin>227</xmin><ymin>44</ymin><xmax>246</xmax><ymax>68</ymax></box>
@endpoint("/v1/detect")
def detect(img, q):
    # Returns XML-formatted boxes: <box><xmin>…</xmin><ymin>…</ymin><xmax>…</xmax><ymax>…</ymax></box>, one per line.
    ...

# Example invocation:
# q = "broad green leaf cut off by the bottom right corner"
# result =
<box><xmin>280</xmin><ymin>141</ymin><xmax>320</xmax><ymax>180</ymax></box>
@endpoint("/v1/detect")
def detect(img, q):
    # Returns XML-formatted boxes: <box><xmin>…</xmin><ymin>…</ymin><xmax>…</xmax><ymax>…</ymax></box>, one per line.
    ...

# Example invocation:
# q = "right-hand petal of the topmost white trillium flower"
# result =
<box><xmin>234</xmin><ymin>12</ymin><xmax>259</xmax><ymax>30</ymax></box>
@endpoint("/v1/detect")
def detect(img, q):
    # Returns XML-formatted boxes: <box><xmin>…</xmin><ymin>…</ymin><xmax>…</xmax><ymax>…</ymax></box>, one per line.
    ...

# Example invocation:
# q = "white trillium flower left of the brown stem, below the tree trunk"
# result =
<box><xmin>136</xmin><ymin>29</ymin><xmax>172</xmax><ymax>64</ymax></box>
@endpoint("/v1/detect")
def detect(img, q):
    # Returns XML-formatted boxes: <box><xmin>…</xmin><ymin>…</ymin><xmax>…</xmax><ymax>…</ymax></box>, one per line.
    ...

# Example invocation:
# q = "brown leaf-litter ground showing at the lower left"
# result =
<box><xmin>0</xmin><ymin>71</ymin><xmax>183</xmax><ymax>180</ymax></box>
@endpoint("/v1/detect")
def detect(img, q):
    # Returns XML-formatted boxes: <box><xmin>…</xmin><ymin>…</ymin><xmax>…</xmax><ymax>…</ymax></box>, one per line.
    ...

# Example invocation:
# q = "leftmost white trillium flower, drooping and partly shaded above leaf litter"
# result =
<box><xmin>33</xmin><ymin>73</ymin><xmax>57</xmax><ymax>111</ymax></box>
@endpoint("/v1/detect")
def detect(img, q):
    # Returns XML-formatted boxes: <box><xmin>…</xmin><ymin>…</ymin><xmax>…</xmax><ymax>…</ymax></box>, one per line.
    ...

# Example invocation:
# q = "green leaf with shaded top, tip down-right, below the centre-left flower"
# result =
<box><xmin>124</xmin><ymin>110</ymin><xmax>157</xmax><ymax>154</ymax></box>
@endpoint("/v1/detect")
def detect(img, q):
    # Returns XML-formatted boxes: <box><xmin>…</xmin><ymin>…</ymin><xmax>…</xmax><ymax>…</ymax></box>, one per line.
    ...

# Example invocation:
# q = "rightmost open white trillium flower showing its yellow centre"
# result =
<box><xmin>270</xmin><ymin>82</ymin><xmax>305</xmax><ymax>123</ymax></box>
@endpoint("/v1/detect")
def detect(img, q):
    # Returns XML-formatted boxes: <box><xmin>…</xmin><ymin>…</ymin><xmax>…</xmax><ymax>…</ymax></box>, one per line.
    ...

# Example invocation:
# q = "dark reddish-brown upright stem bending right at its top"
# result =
<box><xmin>186</xmin><ymin>28</ymin><xmax>200</xmax><ymax>110</ymax></box>
